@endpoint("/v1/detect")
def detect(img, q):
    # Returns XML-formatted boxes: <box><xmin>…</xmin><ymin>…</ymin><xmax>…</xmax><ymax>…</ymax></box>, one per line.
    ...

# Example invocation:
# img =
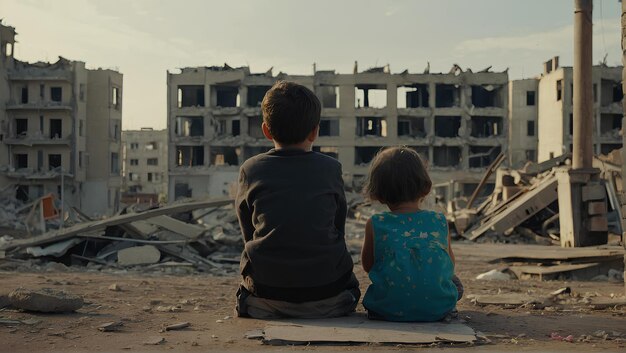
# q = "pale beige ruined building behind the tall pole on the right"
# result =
<box><xmin>537</xmin><ymin>57</ymin><xmax>624</xmax><ymax>162</ymax></box>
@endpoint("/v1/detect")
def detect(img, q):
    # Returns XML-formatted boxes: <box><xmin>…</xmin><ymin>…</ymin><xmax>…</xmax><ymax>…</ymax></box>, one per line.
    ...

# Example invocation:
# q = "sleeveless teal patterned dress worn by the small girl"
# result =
<box><xmin>363</xmin><ymin>210</ymin><xmax>458</xmax><ymax>321</ymax></box>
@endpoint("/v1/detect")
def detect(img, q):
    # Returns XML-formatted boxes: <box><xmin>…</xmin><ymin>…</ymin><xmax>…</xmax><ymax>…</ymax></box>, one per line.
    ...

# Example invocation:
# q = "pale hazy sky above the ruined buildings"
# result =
<box><xmin>0</xmin><ymin>0</ymin><xmax>621</xmax><ymax>130</ymax></box>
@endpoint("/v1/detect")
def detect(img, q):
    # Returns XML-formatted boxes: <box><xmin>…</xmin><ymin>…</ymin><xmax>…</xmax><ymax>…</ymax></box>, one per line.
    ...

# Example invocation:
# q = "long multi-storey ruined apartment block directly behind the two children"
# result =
<box><xmin>167</xmin><ymin>64</ymin><xmax>508</xmax><ymax>201</ymax></box>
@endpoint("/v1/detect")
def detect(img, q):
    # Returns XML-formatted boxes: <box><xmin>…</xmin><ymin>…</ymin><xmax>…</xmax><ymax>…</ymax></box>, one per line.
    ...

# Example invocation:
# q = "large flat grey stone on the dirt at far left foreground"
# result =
<box><xmin>9</xmin><ymin>288</ymin><xmax>84</xmax><ymax>313</ymax></box>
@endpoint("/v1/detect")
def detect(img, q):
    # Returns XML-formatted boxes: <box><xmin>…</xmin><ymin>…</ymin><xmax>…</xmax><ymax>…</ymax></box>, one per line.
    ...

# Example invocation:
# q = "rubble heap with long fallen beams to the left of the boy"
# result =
<box><xmin>0</xmin><ymin>199</ymin><xmax>243</xmax><ymax>275</ymax></box>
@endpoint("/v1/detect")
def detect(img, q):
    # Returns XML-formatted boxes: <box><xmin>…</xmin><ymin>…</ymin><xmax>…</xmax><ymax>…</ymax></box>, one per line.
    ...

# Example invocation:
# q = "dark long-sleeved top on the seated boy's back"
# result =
<box><xmin>235</xmin><ymin>149</ymin><xmax>353</xmax><ymax>302</ymax></box>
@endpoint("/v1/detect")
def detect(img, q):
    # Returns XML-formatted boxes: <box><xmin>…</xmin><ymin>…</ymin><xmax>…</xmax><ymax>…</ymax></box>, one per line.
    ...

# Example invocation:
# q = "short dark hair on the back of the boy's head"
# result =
<box><xmin>261</xmin><ymin>81</ymin><xmax>322</xmax><ymax>145</ymax></box>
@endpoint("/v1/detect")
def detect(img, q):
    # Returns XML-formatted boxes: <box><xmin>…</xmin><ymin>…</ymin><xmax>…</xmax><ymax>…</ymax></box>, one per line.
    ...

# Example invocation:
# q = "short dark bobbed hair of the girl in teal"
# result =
<box><xmin>363</xmin><ymin>147</ymin><xmax>433</xmax><ymax>205</ymax></box>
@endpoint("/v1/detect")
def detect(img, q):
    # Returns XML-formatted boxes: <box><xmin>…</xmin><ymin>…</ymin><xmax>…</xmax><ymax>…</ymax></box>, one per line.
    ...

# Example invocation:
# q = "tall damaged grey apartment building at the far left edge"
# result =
<box><xmin>0</xmin><ymin>23</ymin><xmax>122</xmax><ymax>215</ymax></box>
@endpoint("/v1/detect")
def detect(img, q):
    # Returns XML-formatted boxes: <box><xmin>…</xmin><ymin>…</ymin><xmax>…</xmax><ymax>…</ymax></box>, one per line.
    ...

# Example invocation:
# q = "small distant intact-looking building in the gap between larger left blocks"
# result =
<box><xmin>122</xmin><ymin>128</ymin><xmax>168</xmax><ymax>204</ymax></box>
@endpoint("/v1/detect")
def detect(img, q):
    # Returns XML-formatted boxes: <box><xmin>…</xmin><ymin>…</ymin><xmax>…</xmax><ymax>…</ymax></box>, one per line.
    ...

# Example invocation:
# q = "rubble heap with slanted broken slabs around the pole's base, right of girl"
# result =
<box><xmin>447</xmin><ymin>154</ymin><xmax>622</xmax><ymax>245</ymax></box>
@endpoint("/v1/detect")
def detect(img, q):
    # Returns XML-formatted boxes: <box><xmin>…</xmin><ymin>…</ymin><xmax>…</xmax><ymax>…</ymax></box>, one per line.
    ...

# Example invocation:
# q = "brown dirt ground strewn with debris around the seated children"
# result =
<box><xmin>0</xmin><ymin>244</ymin><xmax>626</xmax><ymax>352</ymax></box>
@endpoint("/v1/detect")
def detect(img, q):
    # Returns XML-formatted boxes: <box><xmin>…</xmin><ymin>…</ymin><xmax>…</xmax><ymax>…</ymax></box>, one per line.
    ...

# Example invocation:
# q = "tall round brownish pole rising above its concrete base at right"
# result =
<box><xmin>572</xmin><ymin>0</ymin><xmax>593</xmax><ymax>169</ymax></box>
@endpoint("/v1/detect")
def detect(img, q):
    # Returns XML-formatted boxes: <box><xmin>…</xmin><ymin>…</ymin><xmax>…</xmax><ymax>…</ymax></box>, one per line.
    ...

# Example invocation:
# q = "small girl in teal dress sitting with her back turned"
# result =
<box><xmin>361</xmin><ymin>147</ymin><xmax>462</xmax><ymax>321</ymax></box>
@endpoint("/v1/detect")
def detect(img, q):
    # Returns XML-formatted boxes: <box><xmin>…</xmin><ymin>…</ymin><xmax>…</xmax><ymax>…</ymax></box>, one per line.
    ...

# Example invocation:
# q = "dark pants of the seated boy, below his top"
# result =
<box><xmin>235</xmin><ymin>274</ymin><xmax>361</xmax><ymax>319</ymax></box>
